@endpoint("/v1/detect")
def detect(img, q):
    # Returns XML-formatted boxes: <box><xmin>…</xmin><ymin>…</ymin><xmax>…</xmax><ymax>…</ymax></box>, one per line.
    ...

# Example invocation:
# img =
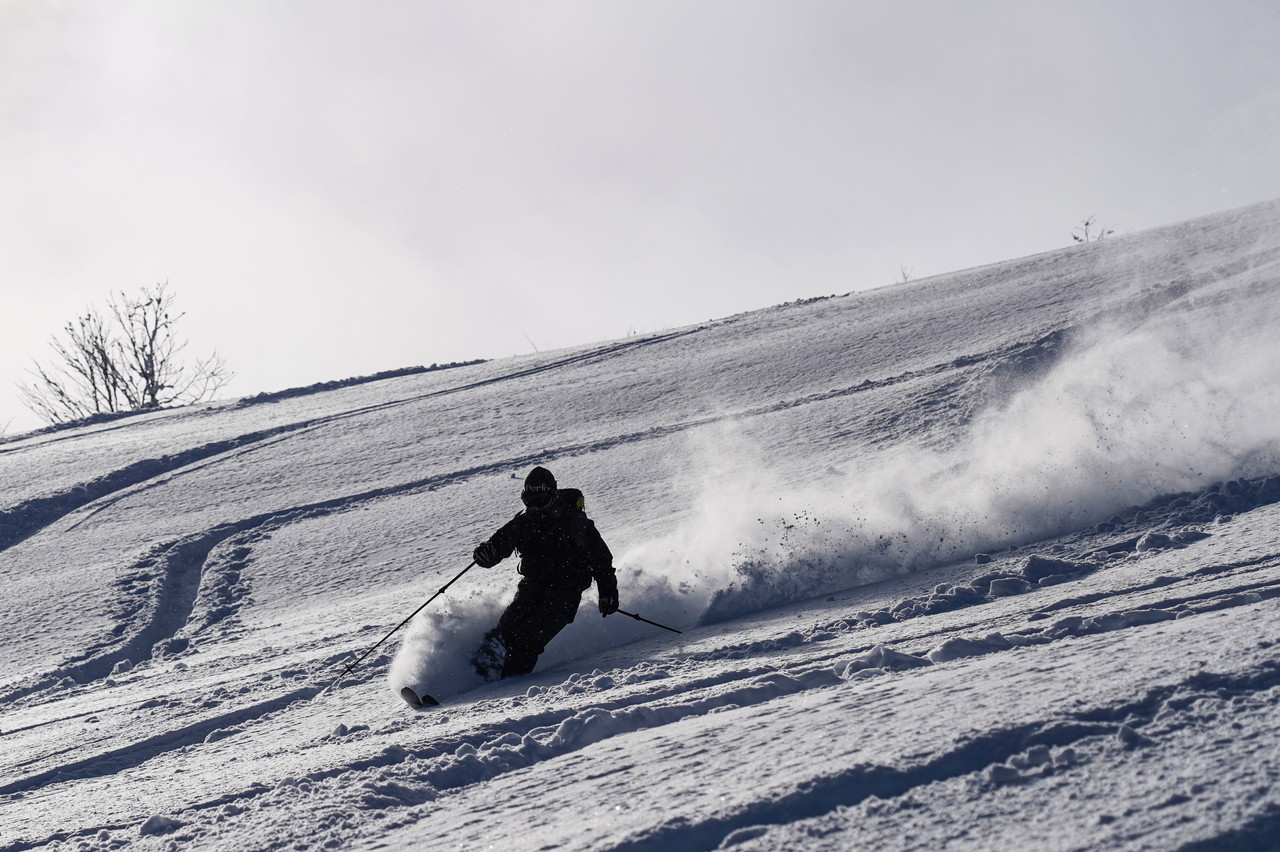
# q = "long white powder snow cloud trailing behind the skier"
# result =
<box><xmin>623</xmin><ymin>295</ymin><xmax>1280</xmax><ymax>623</ymax></box>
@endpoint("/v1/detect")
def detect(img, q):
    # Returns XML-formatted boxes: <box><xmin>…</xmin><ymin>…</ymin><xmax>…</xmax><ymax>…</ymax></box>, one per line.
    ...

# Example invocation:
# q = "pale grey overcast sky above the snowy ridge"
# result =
<box><xmin>0</xmin><ymin>0</ymin><xmax>1280</xmax><ymax>434</ymax></box>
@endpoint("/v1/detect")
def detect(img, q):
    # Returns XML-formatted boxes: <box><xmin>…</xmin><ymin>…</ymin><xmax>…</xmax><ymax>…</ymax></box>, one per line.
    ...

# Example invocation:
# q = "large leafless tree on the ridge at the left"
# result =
<box><xmin>18</xmin><ymin>284</ymin><xmax>234</xmax><ymax>423</ymax></box>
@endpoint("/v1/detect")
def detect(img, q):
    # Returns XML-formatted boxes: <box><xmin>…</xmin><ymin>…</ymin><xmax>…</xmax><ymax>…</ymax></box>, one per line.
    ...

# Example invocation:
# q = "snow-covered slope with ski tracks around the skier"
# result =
<box><xmin>0</xmin><ymin>202</ymin><xmax>1280</xmax><ymax>852</ymax></box>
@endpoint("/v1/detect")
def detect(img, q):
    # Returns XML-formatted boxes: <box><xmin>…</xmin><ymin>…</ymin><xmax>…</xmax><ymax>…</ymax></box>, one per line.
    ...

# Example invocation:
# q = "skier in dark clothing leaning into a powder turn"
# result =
<box><xmin>471</xmin><ymin>467</ymin><xmax>618</xmax><ymax>681</ymax></box>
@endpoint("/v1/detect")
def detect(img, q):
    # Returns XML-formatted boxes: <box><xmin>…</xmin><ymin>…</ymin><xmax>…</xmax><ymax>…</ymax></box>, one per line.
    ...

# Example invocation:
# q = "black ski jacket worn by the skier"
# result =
<box><xmin>489</xmin><ymin>489</ymin><xmax>617</xmax><ymax>592</ymax></box>
